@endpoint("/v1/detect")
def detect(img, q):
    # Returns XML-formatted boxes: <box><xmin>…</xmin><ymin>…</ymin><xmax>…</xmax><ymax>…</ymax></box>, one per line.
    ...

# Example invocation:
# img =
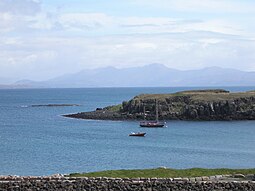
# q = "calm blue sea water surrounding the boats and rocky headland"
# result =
<box><xmin>0</xmin><ymin>87</ymin><xmax>255</xmax><ymax>175</ymax></box>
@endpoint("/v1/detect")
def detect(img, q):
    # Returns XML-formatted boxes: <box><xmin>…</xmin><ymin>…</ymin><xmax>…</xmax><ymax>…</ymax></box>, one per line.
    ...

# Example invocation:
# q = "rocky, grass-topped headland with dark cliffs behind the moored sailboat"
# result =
<box><xmin>64</xmin><ymin>89</ymin><xmax>255</xmax><ymax>121</ymax></box>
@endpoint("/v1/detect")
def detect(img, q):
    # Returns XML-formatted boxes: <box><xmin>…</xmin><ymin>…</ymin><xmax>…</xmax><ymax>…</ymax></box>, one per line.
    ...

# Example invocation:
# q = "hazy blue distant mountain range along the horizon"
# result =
<box><xmin>0</xmin><ymin>64</ymin><xmax>255</xmax><ymax>88</ymax></box>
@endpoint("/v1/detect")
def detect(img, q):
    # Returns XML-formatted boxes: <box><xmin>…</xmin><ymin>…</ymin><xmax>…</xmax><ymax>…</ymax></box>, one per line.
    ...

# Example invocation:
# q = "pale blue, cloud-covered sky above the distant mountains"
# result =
<box><xmin>0</xmin><ymin>0</ymin><xmax>255</xmax><ymax>83</ymax></box>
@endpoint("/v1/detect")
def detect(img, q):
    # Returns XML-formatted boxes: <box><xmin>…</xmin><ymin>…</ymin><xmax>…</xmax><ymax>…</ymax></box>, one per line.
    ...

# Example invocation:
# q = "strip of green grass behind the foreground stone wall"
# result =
<box><xmin>70</xmin><ymin>168</ymin><xmax>255</xmax><ymax>178</ymax></box>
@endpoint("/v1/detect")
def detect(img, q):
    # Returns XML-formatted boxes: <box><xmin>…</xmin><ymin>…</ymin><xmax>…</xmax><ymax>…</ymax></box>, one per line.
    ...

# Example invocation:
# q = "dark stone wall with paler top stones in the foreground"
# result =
<box><xmin>0</xmin><ymin>174</ymin><xmax>255</xmax><ymax>191</ymax></box>
